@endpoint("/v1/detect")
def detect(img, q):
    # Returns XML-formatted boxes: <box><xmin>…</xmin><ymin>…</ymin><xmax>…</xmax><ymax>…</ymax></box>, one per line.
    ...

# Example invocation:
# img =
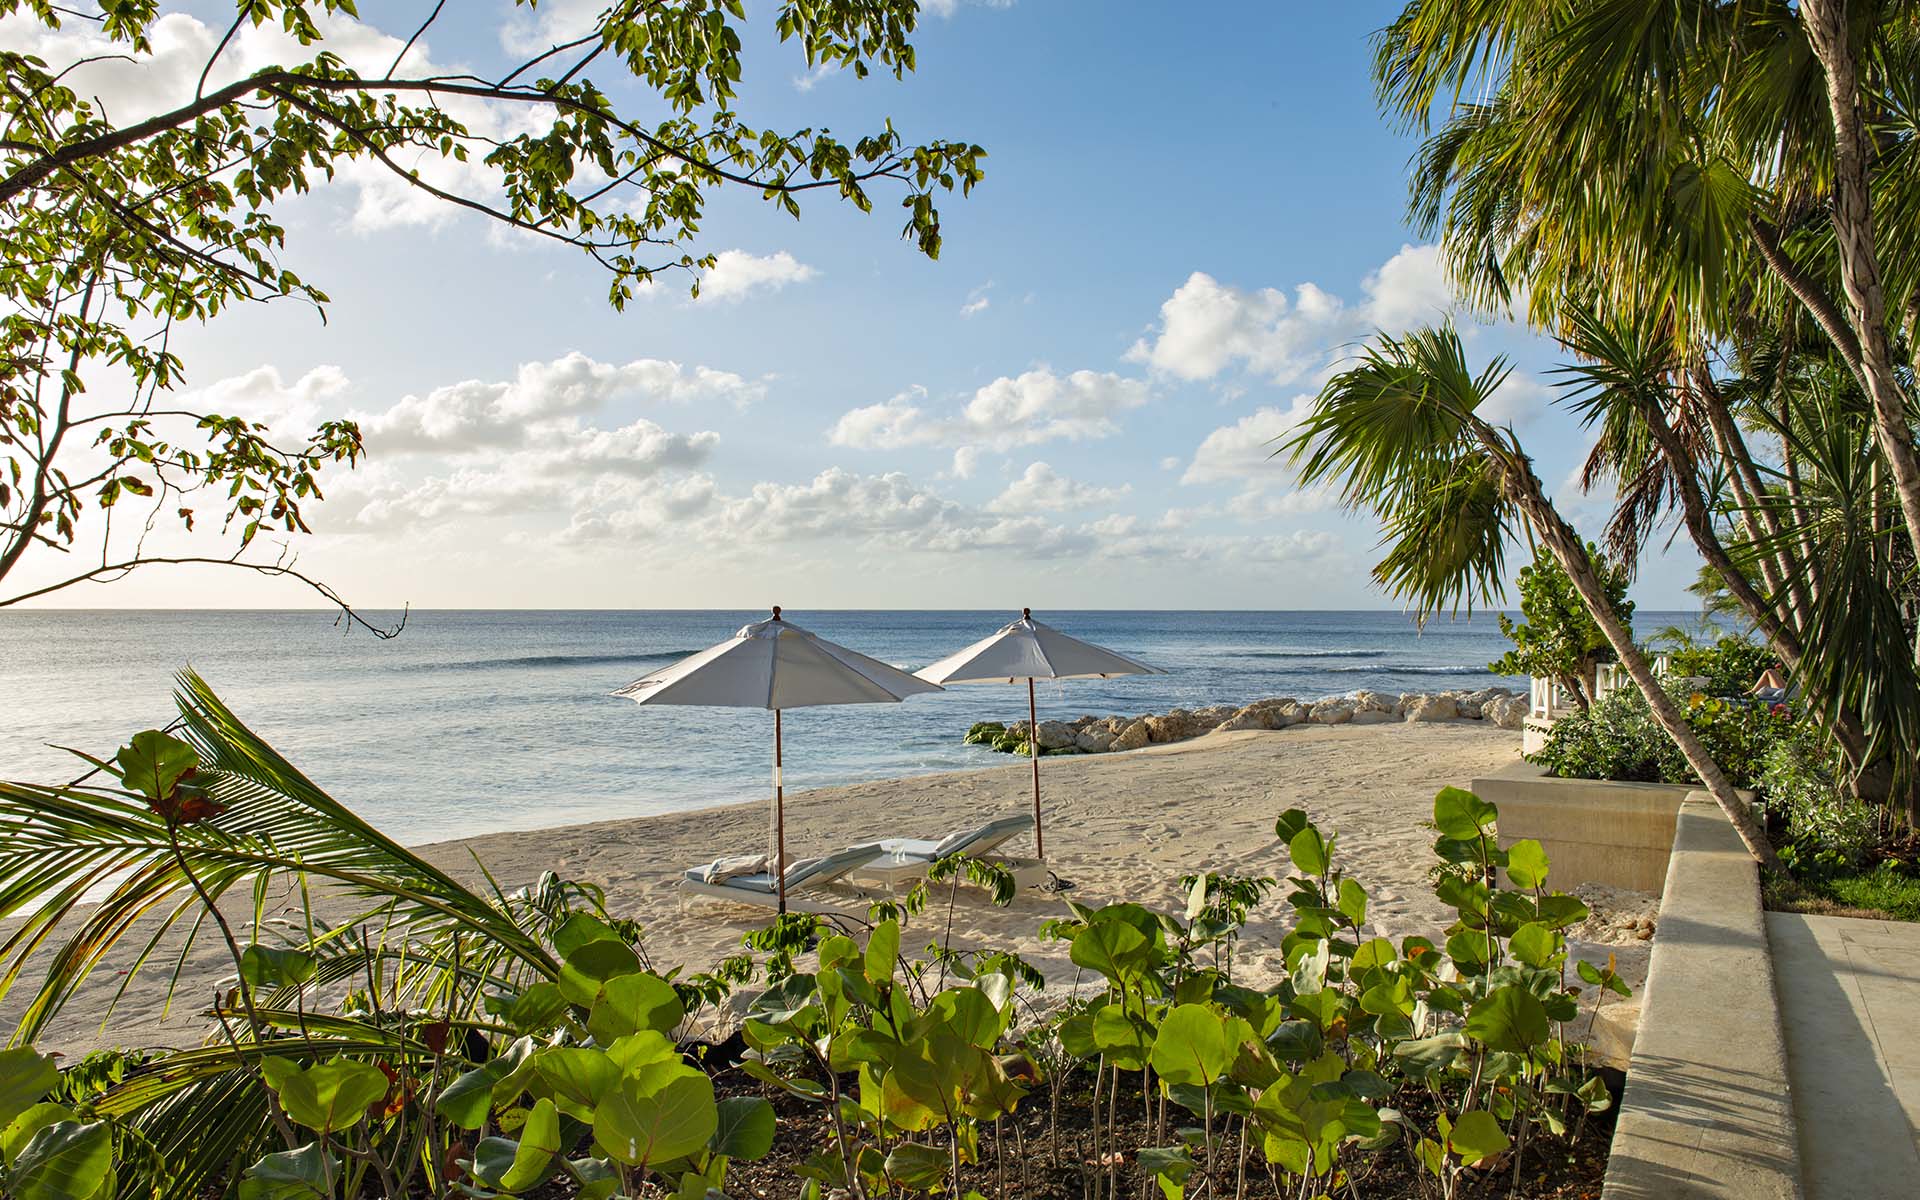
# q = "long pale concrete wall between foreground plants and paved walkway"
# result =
<box><xmin>1597</xmin><ymin>791</ymin><xmax>1801</xmax><ymax>1200</ymax></box>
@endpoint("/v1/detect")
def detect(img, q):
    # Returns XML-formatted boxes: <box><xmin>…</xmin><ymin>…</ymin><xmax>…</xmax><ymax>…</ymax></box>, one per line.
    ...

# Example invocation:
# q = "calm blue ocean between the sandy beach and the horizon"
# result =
<box><xmin>0</xmin><ymin>611</ymin><xmax>1663</xmax><ymax>843</ymax></box>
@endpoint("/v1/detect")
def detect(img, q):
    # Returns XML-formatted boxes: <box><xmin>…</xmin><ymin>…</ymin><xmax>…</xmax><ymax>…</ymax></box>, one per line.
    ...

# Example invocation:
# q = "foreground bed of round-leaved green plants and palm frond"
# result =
<box><xmin>0</xmin><ymin>674</ymin><xmax>1628</xmax><ymax>1200</ymax></box>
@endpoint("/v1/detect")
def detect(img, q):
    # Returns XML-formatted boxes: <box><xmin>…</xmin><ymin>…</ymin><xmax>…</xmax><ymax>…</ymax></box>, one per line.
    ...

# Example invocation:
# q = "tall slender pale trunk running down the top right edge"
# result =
<box><xmin>1801</xmin><ymin>0</ymin><xmax>1920</xmax><ymax>560</ymax></box>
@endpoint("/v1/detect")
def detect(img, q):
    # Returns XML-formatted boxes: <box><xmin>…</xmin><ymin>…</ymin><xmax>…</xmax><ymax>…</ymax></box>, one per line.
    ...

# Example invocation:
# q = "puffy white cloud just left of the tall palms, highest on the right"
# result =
<box><xmin>1127</xmin><ymin>246</ymin><xmax>1448</xmax><ymax>384</ymax></box>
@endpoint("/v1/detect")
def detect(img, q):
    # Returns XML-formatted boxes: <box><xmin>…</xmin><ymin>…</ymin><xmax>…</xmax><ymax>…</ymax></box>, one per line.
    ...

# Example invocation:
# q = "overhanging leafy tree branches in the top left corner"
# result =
<box><xmin>0</xmin><ymin>0</ymin><xmax>985</xmax><ymax>634</ymax></box>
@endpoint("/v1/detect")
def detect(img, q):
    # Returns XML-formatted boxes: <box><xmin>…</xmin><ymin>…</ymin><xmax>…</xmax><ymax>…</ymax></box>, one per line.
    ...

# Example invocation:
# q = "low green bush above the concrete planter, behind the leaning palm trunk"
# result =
<box><xmin>1528</xmin><ymin>687</ymin><xmax>1791</xmax><ymax>789</ymax></box>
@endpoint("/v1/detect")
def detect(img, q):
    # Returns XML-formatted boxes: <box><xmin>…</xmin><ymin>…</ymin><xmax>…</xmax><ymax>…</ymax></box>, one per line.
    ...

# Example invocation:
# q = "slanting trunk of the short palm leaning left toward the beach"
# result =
<box><xmin>1480</xmin><ymin>445</ymin><xmax>1780</xmax><ymax>868</ymax></box>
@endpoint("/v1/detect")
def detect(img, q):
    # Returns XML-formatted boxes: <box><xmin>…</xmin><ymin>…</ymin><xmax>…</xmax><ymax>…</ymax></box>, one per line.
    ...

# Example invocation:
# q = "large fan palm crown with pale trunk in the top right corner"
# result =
<box><xmin>1375</xmin><ymin>0</ymin><xmax>1920</xmax><ymax>572</ymax></box>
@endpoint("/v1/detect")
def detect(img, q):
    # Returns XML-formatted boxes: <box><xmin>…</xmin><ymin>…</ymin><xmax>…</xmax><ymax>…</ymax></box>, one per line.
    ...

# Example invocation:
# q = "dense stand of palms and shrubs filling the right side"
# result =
<box><xmin>1281</xmin><ymin>2</ymin><xmax>1920</xmax><ymax>866</ymax></box>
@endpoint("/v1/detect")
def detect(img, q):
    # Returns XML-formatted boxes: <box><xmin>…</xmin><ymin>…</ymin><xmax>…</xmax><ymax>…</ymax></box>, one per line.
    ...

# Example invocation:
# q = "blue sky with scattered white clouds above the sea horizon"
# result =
<box><xmin>0</xmin><ymin>0</ymin><xmax>1693</xmax><ymax>611</ymax></box>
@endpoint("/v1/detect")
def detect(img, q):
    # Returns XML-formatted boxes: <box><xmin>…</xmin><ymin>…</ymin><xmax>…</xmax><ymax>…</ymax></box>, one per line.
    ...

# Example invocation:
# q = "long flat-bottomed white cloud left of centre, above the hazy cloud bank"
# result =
<box><xmin>361</xmin><ymin>351</ymin><xmax>766</xmax><ymax>453</ymax></box>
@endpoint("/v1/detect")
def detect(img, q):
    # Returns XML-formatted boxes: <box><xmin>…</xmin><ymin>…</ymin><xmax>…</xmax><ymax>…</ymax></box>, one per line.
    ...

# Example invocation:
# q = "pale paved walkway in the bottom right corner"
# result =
<box><xmin>1766</xmin><ymin>912</ymin><xmax>1920</xmax><ymax>1200</ymax></box>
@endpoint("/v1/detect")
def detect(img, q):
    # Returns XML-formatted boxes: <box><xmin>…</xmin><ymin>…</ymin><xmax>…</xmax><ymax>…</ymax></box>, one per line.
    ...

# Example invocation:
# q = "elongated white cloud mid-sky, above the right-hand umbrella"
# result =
<box><xmin>828</xmin><ymin>367</ymin><xmax>1148</xmax><ymax>451</ymax></box>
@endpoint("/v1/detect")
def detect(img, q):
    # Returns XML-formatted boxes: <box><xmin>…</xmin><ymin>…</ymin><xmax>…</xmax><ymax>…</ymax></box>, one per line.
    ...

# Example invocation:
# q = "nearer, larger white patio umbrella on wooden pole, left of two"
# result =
<box><xmin>614</xmin><ymin>605</ymin><xmax>941</xmax><ymax>912</ymax></box>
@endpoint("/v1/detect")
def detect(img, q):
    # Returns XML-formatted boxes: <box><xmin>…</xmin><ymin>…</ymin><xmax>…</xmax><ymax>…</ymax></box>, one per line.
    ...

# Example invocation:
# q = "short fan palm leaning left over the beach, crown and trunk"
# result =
<box><xmin>1281</xmin><ymin>324</ymin><xmax>1778</xmax><ymax>866</ymax></box>
